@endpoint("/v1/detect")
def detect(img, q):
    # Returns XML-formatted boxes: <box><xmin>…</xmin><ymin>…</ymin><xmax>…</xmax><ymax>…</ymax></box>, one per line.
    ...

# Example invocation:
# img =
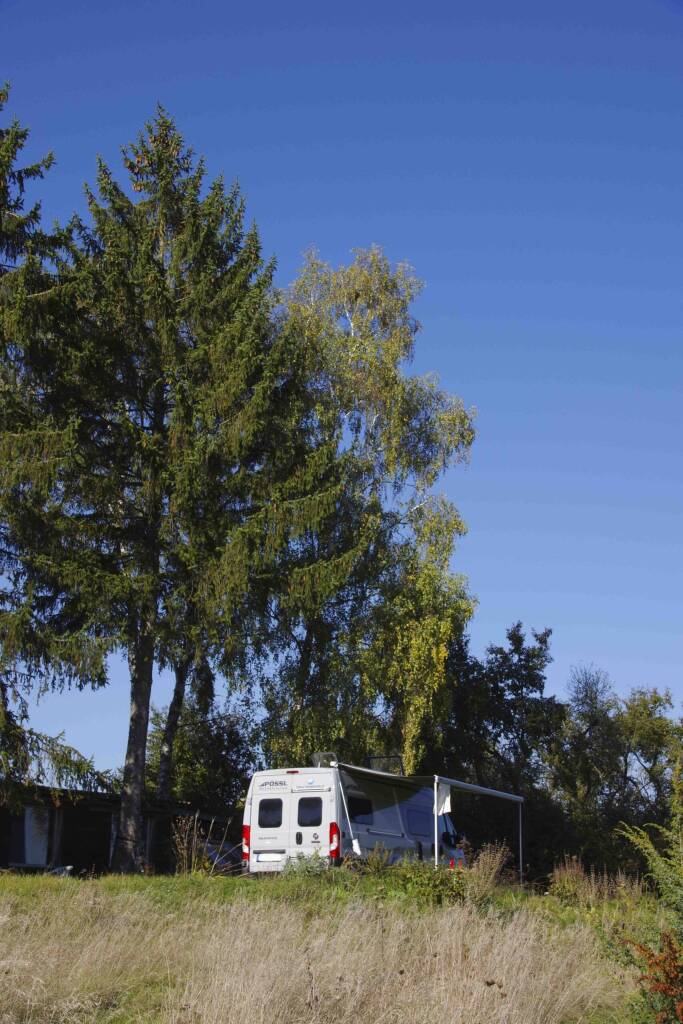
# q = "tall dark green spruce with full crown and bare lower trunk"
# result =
<box><xmin>0</xmin><ymin>110</ymin><xmax>350</xmax><ymax>870</ymax></box>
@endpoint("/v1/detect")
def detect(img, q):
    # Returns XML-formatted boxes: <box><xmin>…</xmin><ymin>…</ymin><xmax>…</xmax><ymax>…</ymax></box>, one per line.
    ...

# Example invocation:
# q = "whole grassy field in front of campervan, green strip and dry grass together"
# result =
<box><xmin>0</xmin><ymin>869</ymin><xmax>657</xmax><ymax>1024</ymax></box>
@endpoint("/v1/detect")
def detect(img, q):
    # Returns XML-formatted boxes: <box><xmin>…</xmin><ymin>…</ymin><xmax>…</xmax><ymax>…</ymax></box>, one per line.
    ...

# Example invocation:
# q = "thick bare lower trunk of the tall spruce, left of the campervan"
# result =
<box><xmin>112</xmin><ymin>627</ymin><xmax>155</xmax><ymax>872</ymax></box>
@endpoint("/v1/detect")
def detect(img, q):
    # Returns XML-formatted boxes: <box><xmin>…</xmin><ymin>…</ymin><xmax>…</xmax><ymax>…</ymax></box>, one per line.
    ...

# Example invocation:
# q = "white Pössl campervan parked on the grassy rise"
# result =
<box><xmin>242</xmin><ymin>761</ymin><xmax>457</xmax><ymax>872</ymax></box>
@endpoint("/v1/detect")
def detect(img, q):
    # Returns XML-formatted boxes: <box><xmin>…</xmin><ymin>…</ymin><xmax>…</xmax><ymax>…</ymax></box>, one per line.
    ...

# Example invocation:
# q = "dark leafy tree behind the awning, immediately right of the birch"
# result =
<box><xmin>420</xmin><ymin>623</ymin><xmax>564</xmax><ymax>878</ymax></box>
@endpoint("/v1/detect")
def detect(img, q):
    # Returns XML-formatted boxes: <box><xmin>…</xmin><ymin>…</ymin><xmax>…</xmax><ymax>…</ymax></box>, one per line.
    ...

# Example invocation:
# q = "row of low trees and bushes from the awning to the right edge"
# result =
<box><xmin>422</xmin><ymin>623</ymin><xmax>681</xmax><ymax>879</ymax></box>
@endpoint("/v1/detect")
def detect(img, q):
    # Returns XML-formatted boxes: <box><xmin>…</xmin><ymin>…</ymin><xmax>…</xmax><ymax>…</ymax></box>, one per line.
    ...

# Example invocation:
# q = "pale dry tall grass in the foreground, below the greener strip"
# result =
<box><xmin>0</xmin><ymin>880</ymin><xmax>630</xmax><ymax>1024</ymax></box>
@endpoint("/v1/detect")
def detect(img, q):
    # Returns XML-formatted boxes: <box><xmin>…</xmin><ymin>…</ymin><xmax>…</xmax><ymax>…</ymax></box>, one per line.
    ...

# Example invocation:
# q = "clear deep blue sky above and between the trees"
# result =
<box><xmin>6</xmin><ymin>0</ymin><xmax>683</xmax><ymax>766</ymax></box>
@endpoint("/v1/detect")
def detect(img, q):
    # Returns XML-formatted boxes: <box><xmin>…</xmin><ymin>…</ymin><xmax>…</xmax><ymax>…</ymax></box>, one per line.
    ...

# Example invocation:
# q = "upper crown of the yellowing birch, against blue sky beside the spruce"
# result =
<box><xmin>286</xmin><ymin>248</ymin><xmax>473</xmax><ymax>488</ymax></box>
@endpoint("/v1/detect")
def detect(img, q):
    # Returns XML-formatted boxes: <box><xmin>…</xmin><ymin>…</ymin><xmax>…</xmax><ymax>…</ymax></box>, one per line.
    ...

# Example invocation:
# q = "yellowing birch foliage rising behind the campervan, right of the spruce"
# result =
<box><xmin>264</xmin><ymin>248</ymin><xmax>473</xmax><ymax>770</ymax></box>
